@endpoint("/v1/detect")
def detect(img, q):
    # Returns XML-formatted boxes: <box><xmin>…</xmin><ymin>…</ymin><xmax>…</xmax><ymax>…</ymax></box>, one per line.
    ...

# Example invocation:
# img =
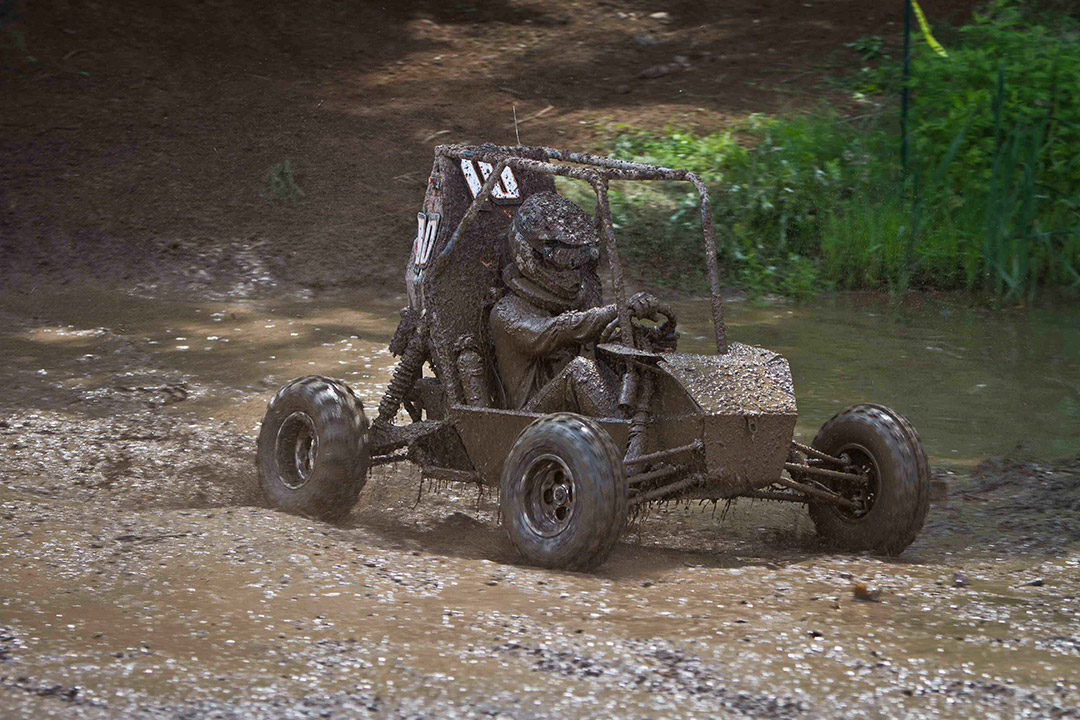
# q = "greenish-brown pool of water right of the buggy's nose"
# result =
<box><xmin>679</xmin><ymin>298</ymin><xmax>1080</xmax><ymax>466</ymax></box>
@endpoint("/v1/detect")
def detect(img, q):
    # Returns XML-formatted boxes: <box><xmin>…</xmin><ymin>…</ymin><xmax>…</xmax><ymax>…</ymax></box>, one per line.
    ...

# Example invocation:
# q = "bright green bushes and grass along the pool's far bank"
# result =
<box><xmin>612</xmin><ymin>0</ymin><xmax>1080</xmax><ymax>301</ymax></box>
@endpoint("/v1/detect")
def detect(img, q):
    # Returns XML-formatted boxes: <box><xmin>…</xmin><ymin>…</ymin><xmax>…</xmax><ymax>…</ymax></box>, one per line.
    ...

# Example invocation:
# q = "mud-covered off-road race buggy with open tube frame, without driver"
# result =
<box><xmin>258</xmin><ymin>145</ymin><xmax>930</xmax><ymax>570</ymax></box>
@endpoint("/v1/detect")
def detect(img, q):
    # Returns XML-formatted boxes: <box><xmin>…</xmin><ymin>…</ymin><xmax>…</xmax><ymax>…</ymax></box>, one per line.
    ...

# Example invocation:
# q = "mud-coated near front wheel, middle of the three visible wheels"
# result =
<box><xmin>499</xmin><ymin>412</ymin><xmax>627</xmax><ymax>570</ymax></box>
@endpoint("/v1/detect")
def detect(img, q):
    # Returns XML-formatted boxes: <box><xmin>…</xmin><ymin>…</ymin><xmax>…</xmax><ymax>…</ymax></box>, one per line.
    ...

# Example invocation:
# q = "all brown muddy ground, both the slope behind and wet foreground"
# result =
<box><xmin>6</xmin><ymin>0</ymin><xmax>1080</xmax><ymax>718</ymax></box>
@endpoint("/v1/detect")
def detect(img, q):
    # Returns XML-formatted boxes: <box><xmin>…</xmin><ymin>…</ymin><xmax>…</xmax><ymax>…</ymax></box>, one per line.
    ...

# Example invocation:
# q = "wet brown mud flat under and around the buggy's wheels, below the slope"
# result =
<box><xmin>0</xmin><ymin>291</ymin><xmax>1080</xmax><ymax>718</ymax></box>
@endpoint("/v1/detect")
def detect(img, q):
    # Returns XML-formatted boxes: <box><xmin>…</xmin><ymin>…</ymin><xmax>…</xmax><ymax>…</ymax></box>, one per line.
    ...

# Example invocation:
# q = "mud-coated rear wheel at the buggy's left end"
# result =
<box><xmin>258</xmin><ymin>375</ymin><xmax>370</xmax><ymax>522</ymax></box>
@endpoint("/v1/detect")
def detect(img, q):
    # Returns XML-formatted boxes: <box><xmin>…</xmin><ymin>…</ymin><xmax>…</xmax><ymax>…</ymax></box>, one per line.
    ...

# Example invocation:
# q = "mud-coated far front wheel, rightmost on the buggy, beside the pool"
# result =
<box><xmin>810</xmin><ymin>405</ymin><xmax>930</xmax><ymax>555</ymax></box>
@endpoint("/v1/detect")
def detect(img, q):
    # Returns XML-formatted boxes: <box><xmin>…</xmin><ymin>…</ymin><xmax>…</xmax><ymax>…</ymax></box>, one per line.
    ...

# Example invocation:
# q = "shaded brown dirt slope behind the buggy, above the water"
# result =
<box><xmin>0</xmin><ymin>0</ymin><xmax>971</xmax><ymax>295</ymax></box>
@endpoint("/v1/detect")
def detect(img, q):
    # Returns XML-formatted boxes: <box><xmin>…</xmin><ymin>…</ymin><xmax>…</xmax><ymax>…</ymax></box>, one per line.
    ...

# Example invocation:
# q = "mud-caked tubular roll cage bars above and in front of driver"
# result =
<box><xmin>435</xmin><ymin>145</ymin><xmax>728</xmax><ymax>355</ymax></box>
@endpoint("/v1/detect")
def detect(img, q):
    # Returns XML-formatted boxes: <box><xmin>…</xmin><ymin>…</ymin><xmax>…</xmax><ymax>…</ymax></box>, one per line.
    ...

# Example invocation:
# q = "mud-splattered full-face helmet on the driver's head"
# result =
<box><xmin>507</xmin><ymin>192</ymin><xmax>599</xmax><ymax>298</ymax></box>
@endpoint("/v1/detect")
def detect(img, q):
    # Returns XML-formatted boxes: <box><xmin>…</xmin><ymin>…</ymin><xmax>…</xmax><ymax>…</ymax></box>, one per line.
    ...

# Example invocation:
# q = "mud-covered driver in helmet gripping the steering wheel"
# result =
<box><xmin>489</xmin><ymin>192</ymin><xmax>660</xmax><ymax>418</ymax></box>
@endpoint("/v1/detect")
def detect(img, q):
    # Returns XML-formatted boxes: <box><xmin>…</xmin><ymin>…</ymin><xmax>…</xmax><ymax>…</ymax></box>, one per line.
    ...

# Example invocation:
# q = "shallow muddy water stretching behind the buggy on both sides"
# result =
<box><xmin>0</xmin><ymin>293</ymin><xmax>1080</xmax><ymax>466</ymax></box>
